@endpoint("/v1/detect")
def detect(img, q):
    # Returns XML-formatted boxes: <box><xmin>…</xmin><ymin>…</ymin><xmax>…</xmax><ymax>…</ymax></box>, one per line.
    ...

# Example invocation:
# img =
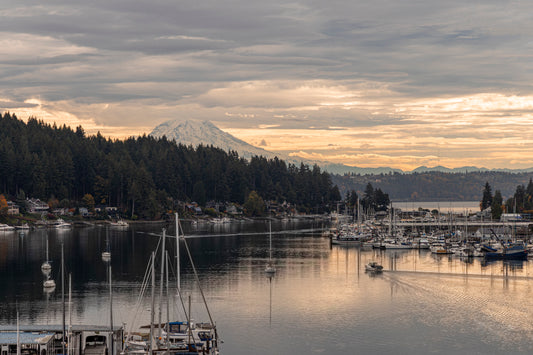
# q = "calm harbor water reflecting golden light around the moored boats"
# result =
<box><xmin>0</xmin><ymin>222</ymin><xmax>533</xmax><ymax>355</ymax></box>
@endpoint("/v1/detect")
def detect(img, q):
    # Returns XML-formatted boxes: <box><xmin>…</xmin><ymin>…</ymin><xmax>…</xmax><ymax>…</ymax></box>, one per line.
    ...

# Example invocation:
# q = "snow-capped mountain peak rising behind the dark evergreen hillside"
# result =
<box><xmin>150</xmin><ymin>120</ymin><xmax>284</xmax><ymax>160</ymax></box>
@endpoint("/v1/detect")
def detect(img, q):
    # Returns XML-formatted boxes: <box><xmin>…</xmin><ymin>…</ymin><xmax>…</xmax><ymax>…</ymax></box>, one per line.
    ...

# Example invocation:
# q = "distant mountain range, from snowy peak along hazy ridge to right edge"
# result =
<box><xmin>150</xmin><ymin>120</ymin><xmax>533</xmax><ymax>175</ymax></box>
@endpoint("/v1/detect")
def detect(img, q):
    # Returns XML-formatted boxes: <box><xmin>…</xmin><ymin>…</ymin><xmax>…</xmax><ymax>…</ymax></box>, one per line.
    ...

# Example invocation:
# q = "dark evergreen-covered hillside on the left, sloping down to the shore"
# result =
<box><xmin>0</xmin><ymin>113</ymin><xmax>341</xmax><ymax>218</ymax></box>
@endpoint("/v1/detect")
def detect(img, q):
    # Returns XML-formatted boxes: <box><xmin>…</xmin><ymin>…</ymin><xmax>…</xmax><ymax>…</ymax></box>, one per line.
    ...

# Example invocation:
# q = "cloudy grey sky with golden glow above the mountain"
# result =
<box><xmin>0</xmin><ymin>0</ymin><xmax>533</xmax><ymax>170</ymax></box>
